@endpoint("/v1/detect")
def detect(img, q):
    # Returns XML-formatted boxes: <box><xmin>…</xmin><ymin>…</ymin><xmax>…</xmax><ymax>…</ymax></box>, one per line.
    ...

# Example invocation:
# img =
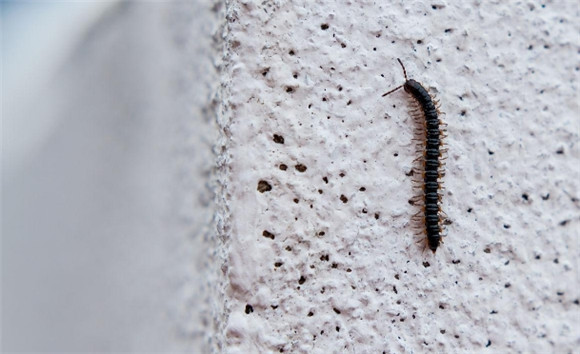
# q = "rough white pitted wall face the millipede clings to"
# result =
<box><xmin>219</xmin><ymin>1</ymin><xmax>580</xmax><ymax>353</ymax></box>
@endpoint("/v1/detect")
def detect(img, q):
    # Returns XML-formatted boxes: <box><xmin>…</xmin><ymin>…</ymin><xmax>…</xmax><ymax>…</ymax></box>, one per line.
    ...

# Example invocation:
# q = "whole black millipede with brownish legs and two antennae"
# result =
<box><xmin>382</xmin><ymin>58</ymin><xmax>447</xmax><ymax>253</ymax></box>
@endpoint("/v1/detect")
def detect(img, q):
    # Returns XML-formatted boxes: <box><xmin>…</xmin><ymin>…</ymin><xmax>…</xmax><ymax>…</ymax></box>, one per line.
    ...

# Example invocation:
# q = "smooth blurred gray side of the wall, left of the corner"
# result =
<box><xmin>1</xmin><ymin>1</ymin><xmax>219</xmax><ymax>352</ymax></box>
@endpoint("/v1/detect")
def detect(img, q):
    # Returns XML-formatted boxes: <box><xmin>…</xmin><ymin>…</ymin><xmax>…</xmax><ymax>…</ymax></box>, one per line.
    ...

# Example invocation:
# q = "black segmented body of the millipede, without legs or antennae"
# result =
<box><xmin>403</xmin><ymin>79</ymin><xmax>441</xmax><ymax>252</ymax></box>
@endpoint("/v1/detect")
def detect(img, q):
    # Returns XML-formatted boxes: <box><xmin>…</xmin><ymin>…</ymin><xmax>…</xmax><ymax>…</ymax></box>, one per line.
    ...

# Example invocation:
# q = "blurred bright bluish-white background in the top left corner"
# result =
<box><xmin>0</xmin><ymin>0</ymin><xmax>118</xmax><ymax>174</ymax></box>
